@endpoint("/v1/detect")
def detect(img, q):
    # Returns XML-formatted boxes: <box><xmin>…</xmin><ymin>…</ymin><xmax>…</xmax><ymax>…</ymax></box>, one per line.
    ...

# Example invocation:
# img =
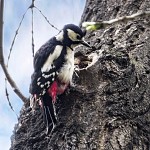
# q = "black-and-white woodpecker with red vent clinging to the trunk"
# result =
<box><xmin>30</xmin><ymin>24</ymin><xmax>90</xmax><ymax>133</ymax></box>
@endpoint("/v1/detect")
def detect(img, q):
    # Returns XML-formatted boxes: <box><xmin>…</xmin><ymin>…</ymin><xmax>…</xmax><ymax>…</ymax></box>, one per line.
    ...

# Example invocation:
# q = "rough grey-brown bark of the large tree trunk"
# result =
<box><xmin>10</xmin><ymin>0</ymin><xmax>150</xmax><ymax>150</ymax></box>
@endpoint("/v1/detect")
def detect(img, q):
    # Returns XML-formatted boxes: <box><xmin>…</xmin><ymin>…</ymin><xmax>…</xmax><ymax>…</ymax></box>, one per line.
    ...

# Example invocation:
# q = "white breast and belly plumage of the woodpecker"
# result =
<box><xmin>58</xmin><ymin>47</ymin><xmax>74</xmax><ymax>83</ymax></box>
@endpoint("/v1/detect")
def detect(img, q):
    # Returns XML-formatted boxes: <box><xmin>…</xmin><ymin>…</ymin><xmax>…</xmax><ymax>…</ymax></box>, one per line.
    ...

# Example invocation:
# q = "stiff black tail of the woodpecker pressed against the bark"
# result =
<box><xmin>42</xmin><ymin>94</ymin><xmax>57</xmax><ymax>134</ymax></box>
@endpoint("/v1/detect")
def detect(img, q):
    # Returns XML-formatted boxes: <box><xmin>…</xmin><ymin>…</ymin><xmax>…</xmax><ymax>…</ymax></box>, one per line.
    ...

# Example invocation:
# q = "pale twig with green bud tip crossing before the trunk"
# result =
<box><xmin>82</xmin><ymin>11</ymin><xmax>150</xmax><ymax>30</ymax></box>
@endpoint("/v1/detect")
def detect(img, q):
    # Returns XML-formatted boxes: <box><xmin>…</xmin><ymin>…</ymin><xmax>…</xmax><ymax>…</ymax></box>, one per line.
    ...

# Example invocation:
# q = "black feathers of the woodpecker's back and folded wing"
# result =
<box><xmin>29</xmin><ymin>37</ymin><xmax>66</xmax><ymax>94</ymax></box>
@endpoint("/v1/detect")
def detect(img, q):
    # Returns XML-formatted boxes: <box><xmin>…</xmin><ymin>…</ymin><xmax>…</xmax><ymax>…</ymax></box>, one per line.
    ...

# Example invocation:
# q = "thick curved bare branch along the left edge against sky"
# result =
<box><xmin>0</xmin><ymin>0</ymin><xmax>28</xmax><ymax>103</ymax></box>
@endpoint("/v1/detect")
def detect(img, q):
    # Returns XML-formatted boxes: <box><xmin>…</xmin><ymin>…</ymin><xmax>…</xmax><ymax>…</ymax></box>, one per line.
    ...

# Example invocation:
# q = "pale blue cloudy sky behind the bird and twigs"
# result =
<box><xmin>0</xmin><ymin>0</ymin><xmax>86</xmax><ymax>150</ymax></box>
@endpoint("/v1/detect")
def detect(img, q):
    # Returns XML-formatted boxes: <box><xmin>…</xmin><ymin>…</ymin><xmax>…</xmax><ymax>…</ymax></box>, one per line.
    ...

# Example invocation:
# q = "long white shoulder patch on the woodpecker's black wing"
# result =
<box><xmin>41</xmin><ymin>45</ymin><xmax>63</xmax><ymax>72</ymax></box>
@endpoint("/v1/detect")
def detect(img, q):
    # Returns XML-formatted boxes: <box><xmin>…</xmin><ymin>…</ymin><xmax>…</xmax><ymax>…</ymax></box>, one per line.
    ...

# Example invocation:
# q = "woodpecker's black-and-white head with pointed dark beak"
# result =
<box><xmin>56</xmin><ymin>24</ymin><xmax>91</xmax><ymax>48</ymax></box>
